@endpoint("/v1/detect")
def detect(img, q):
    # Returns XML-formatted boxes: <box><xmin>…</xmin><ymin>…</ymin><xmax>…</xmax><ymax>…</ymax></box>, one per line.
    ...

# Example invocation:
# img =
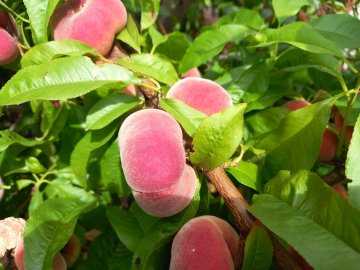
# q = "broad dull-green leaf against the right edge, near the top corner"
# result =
<box><xmin>311</xmin><ymin>14</ymin><xmax>360</xmax><ymax>49</ymax></box>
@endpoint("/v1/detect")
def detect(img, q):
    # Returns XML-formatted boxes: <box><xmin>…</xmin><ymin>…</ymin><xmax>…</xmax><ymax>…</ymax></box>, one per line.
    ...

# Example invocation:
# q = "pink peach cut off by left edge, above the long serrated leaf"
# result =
<box><xmin>0</xmin><ymin>27</ymin><xmax>19</xmax><ymax>65</ymax></box>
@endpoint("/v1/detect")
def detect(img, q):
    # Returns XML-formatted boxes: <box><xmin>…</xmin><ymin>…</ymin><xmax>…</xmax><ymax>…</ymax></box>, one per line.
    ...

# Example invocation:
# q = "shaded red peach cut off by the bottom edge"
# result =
<box><xmin>170</xmin><ymin>216</ymin><xmax>240</xmax><ymax>270</ymax></box>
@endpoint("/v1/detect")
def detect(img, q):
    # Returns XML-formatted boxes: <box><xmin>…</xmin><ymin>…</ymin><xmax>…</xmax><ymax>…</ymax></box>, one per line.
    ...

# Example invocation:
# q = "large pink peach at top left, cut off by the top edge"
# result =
<box><xmin>52</xmin><ymin>0</ymin><xmax>127</xmax><ymax>55</ymax></box>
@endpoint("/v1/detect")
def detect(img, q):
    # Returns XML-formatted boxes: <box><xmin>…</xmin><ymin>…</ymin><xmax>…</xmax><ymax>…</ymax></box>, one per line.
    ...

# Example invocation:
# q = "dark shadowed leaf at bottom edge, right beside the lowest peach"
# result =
<box><xmin>241</xmin><ymin>226</ymin><xmax>273</xmax><ymax>270</ymax></box>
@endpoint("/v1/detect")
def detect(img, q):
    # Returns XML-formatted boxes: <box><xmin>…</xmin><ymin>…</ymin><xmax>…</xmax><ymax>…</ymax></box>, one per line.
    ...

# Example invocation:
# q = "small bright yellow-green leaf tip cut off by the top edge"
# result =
<box><xmin>272</xmin><ymin>0</ymin><xmax>310</xmax><ymax>22</ymax></box>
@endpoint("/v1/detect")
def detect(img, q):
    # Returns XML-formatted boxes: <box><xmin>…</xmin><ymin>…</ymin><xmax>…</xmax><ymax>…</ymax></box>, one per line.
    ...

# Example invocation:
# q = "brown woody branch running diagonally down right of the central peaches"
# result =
<box><xmin>206</xmin><ymin>167</ymin><xmax>302</xmax><ymax>270</ymax></box>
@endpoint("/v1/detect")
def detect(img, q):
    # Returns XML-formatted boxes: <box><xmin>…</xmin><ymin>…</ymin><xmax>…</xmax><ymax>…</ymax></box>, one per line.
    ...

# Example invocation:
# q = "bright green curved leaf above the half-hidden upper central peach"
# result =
<box><xmin>179</xmin><ymin>24</ymin><xmax>251</xmax><ymax>73</ymax></box>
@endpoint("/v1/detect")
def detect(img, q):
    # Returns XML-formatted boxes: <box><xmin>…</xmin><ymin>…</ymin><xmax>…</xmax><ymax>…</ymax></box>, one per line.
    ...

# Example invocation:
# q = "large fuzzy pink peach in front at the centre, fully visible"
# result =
<box><xmin>118</xmin><ymin>109</ymin><xmax>185</xmax><ymax>193</ymax></box>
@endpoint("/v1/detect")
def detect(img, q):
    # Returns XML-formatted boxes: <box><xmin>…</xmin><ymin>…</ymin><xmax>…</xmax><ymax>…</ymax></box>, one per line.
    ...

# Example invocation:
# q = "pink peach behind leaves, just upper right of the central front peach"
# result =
<box><xmin>167</xmin><ymin>77</ymin><xmax>232</xmax><ymax>115</ymax></box>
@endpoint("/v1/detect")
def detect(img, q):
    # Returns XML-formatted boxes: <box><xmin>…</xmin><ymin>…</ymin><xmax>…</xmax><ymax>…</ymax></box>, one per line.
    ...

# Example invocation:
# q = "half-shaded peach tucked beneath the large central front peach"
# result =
<box><xmin>133</xmin><ymin>165</ymin><xmax>197</xmax><ymax>217</ymax></box>
